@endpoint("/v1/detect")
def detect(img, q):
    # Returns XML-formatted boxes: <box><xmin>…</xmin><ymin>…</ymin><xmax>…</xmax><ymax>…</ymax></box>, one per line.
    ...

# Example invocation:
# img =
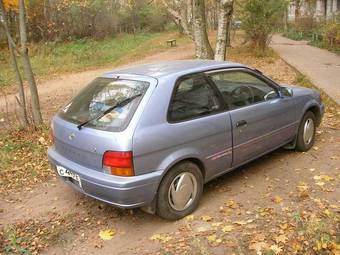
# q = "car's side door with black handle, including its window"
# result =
<box><xmin>209</xmin><ymin>69</ymin><xmax>296</xmax><ymax>166</ymax></box>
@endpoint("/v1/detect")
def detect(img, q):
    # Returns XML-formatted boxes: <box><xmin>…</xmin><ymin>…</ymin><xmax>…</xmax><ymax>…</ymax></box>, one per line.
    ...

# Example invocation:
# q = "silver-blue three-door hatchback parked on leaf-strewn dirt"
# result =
<box><xmin>48</xmin><ymin>60</ymin><xmax>324</xmax><ymax>220</ymax></box>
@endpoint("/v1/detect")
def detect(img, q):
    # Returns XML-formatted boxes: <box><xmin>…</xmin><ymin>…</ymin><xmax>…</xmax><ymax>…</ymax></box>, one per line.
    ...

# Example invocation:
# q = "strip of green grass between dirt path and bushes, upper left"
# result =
<box><xmin>0</xmin><ymin>32</ymin><xmax>187</xmax><ymax>90</ymax></box>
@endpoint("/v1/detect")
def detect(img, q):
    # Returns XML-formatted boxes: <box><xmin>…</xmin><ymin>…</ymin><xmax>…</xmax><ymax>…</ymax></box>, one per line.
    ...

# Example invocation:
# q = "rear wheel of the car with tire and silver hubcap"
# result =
<box><xmin>156</xmin><ymin>161</ymin><xmax>203</xmax><ymax>220</ymax></box>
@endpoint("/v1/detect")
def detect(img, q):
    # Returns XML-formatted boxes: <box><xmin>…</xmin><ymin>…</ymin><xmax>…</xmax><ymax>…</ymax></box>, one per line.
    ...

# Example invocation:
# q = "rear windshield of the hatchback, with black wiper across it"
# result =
<box><xmin>59</xmin><ymin>78</ymin><xmax>149</xmax><ymax>131</ymax></box>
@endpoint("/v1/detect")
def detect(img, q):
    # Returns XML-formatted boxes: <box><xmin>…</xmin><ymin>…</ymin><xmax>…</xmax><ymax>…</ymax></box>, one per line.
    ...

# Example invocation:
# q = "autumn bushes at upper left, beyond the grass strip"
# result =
<box><xmin>0</xmin><ymin>0</ymin><xmax>169</xmax><ymax>42</ymax></box>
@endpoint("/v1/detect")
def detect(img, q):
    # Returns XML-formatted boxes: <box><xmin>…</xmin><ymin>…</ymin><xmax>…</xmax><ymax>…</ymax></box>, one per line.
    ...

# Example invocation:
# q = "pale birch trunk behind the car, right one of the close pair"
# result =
<box><xmin>215</xmin><ymin>0</ymin><xmax>234</xmax><ymax>61</ymax></box>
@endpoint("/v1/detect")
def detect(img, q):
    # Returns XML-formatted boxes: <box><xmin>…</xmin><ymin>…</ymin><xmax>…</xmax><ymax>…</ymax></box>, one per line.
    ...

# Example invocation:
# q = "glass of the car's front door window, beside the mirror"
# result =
<box><xmin>209</xmin><ymin>71</ymin><xmax>278</xmax><ymax>110</ymax></box>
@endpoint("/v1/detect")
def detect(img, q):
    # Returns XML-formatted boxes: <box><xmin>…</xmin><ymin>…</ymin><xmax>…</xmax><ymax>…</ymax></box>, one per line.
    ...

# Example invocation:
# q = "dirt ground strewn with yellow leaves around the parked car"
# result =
<box><xmin>0</xmin><ymin>34</ymin><xmax>340</xmax><ymax>255</ymax></box>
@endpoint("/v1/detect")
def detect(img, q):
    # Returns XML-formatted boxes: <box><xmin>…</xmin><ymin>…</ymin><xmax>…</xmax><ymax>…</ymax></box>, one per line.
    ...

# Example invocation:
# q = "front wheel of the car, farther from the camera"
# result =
<box><xmin>295</xmin><ymin>111</ymin><xmax>316</xmax><ymax>151</ymax></box>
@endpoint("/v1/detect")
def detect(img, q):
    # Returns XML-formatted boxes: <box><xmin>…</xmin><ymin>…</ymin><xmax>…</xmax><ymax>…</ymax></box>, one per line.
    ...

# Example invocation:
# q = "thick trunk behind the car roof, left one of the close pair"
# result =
<box><xmin>193</xmin><ymin>0</ymin><xmax>214</xmax><ymax>59</ymax></box>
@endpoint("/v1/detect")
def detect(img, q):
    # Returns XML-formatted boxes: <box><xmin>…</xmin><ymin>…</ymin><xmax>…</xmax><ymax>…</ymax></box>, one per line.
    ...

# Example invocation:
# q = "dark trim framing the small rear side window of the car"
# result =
<box><xmin>166</xmin><ymin>71</ymin><xmax>227</xmax><ymax>124</ymax></box>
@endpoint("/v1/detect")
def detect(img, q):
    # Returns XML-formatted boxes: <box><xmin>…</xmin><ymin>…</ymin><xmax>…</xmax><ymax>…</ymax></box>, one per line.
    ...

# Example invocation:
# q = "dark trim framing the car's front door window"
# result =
<box><xmin>204</xmin><ymin>67</ymin><xmax>281</xmax><ymax>108</ymax></box>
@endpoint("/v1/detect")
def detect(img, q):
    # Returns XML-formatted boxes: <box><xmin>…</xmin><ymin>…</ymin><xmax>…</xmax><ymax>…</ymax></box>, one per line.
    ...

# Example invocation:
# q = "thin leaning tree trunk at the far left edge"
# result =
<box><xmin>0</xmin><ymin>0</ymin><xmax>29</xmax><ymax>127</ymax></box>
